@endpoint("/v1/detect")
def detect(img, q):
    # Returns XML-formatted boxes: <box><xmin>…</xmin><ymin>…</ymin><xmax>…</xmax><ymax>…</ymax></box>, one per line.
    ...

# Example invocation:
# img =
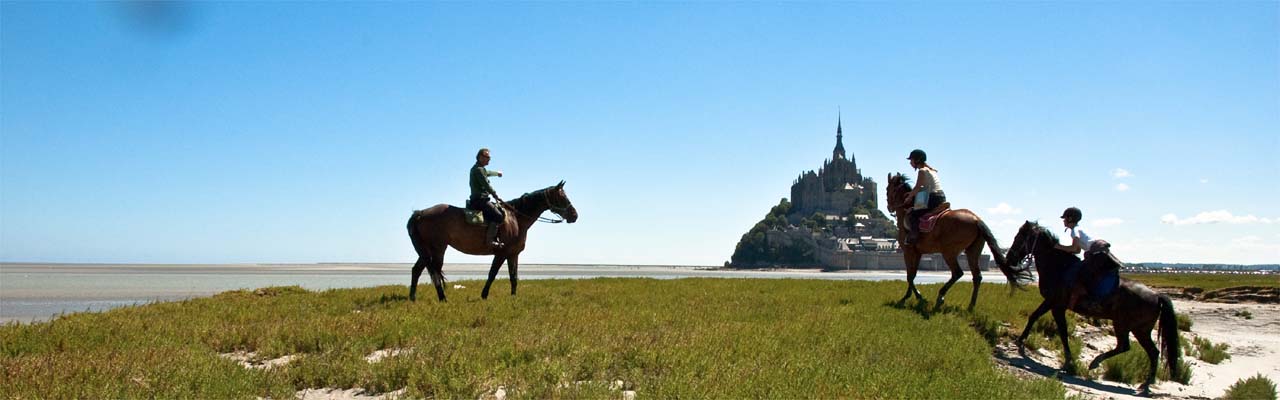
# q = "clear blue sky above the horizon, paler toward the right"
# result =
<box><xmin>0</xmin><ymin>1</ymin><xmax>1280</xmax><ymax>265</ymax></box>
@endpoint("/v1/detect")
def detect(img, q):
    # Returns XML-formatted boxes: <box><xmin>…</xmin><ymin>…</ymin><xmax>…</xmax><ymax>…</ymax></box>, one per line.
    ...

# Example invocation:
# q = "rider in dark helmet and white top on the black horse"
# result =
<box><xmin>1053</xmin><ymin>206</ymin><xmax>1120</xmax><ymax>308</ymax></box>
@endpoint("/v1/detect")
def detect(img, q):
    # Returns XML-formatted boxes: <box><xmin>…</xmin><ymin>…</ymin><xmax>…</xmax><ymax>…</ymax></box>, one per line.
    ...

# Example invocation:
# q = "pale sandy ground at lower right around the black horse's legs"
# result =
<box><xmin>995</xmin><ymin>300</ymin><xmax>1280</xmax><ymax>400</ymax></box>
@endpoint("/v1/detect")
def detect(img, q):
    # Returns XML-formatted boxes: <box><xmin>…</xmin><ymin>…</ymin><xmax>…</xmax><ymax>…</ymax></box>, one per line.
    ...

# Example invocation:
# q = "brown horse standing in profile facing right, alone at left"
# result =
<box><xmin>408</xmin><ymin>181</ymin><xmax>577</xmax><ymax>301</ymax></box>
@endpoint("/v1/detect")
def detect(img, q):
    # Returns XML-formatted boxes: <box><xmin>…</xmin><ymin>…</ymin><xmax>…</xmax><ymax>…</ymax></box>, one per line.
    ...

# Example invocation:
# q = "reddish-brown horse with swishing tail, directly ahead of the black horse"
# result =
<box><xmin>884</xmin><ymin>173</ymin><xmax>1030</xmax><ymax>310</ymax></box>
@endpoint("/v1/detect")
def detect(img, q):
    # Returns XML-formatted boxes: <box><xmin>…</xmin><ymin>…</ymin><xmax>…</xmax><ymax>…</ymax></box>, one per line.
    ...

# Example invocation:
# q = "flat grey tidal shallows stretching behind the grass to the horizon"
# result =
<box><xmin>0</xmin><ymin>263</ymin><xmax>969</xmax><ymax>323</ymax></box>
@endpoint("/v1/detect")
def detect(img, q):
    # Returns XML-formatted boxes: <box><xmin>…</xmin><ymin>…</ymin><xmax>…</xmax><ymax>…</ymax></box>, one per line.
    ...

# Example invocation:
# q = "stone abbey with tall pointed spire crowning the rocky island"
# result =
<box><xmin>788</xmin><ymin>118</ymin><xmax>877</xmax><ymax>218</ymax></box>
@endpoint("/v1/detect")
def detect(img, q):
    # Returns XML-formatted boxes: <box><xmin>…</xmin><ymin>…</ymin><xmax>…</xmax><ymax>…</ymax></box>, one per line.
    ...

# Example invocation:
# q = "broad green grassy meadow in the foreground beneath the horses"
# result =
<box><xmin>0</xmin><ymin>278</ymin><xmax>1064</xmax><ymax>399</ymax></box>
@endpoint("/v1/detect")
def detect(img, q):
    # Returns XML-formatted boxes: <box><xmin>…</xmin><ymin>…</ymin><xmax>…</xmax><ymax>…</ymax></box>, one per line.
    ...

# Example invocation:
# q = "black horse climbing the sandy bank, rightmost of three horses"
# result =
<box><xmin>1009</xmin><ymin>221</ymin><xmax>1179</xmax><ymax>392</ymax></box>
